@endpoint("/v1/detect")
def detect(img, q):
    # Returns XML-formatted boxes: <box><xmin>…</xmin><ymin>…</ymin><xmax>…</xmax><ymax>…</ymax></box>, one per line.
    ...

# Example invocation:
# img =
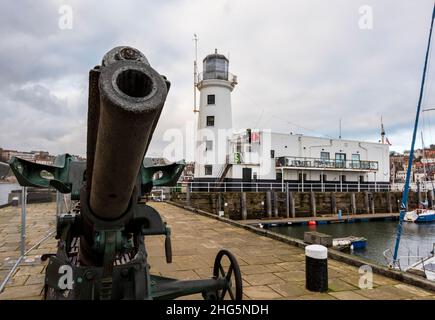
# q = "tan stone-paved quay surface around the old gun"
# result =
<box><xmin>0</xmin><ymin>203</ymin><xmax>435</xmax><ymax>300</ymax></box>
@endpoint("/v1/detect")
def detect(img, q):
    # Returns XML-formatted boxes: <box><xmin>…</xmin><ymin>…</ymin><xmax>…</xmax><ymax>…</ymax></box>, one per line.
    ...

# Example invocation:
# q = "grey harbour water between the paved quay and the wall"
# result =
<box><xmin>270</xmin><ymin>221</ymin><xmax>435</xmax><ymax>268</ymax></box>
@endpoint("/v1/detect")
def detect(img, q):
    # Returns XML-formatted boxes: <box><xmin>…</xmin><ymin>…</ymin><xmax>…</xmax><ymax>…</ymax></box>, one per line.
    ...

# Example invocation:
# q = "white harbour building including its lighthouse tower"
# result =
<box><xmin>194</xmin><ymin>51</ymin><xmax>390</xmax><ymax>191</ymax></box>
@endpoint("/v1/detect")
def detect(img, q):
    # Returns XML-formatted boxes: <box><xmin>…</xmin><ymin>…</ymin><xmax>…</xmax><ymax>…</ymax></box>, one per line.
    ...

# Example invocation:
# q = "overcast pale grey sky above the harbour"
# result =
<box><xmin>0</xmin><ymin>0</ymin><xmax>435</xmax><ymax>160</ymax></box>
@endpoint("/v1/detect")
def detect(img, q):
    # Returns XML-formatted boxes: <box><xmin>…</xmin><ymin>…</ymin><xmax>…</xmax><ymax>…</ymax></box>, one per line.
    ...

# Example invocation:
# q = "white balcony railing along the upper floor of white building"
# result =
<box><xmin>275</xmin><ymin>157</ymin><xmax>378</xmax><ymax>171</ymax></box>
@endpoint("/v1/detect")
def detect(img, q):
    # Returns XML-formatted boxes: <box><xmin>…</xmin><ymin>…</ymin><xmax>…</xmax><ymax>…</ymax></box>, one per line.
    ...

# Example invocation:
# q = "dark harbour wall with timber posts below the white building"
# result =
<box><xmin>171</xmin><ymin>191</ymin><xmax>426</xmax><ymax>220</ymax></box>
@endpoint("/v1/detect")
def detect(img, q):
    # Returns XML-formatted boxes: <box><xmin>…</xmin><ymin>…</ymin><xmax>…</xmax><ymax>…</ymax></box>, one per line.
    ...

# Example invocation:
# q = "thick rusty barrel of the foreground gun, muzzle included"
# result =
<box><xmin>88</xmin><ymin>47</ymin><xmax>168</xmax><ymax>220</ymax></box>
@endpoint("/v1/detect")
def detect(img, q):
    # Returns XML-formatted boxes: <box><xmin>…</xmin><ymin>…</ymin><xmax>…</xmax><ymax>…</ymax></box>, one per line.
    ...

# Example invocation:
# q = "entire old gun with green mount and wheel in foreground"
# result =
<box><xmin>10</xmin><ymin>47</ymin><xmax>242</xmax><ymax>300</ymax></box>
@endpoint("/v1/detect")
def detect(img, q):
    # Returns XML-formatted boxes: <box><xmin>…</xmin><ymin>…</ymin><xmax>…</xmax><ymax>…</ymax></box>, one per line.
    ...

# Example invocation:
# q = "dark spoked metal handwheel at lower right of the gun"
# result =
<box><xmin>213</xmin><ymin>250</ymin><xmax>243</xmax><ymax>300</ymax></box>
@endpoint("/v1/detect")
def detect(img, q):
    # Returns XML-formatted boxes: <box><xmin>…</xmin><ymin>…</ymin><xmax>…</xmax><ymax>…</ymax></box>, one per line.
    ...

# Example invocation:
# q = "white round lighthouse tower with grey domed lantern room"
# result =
<box><xmin>195</xmin><ymin>49</ymin><xmax>237</xmax><ymax>179</ymax></box>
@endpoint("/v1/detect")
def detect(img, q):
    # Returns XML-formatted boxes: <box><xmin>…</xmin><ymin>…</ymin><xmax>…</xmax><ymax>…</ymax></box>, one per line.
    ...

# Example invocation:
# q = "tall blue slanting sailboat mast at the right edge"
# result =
<box><xmin>393</xmin><ymin>4</ymin><xmax>435</xmax><ymax>265</ymax></box>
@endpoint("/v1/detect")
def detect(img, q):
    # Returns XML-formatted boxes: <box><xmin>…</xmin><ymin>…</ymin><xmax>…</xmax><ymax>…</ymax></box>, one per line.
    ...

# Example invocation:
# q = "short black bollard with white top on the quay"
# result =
<box><xmin>305</xmin><ymin>244</ymin><xmax>328</xmax><ymax>292</ymax></box>
